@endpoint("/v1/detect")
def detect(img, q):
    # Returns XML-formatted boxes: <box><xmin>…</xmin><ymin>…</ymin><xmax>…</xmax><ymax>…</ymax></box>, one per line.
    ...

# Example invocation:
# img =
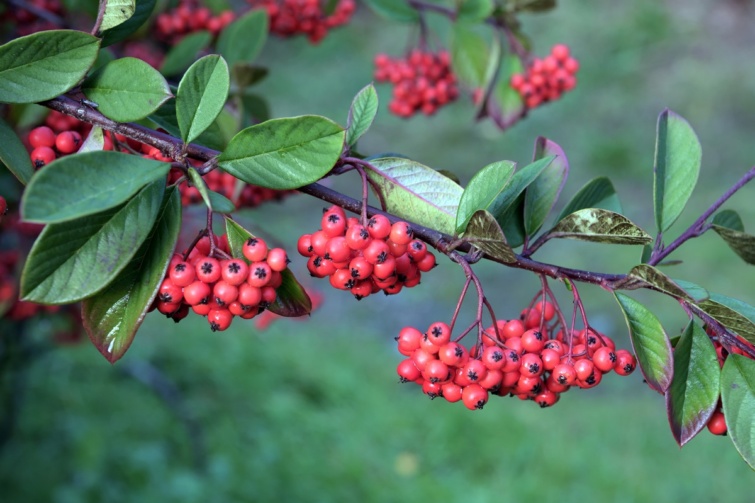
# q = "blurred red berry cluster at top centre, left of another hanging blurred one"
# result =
<box><xmin>375</xmin><ymin>49</ymin><xmax>459</xmax><ymax>117</ymax></box>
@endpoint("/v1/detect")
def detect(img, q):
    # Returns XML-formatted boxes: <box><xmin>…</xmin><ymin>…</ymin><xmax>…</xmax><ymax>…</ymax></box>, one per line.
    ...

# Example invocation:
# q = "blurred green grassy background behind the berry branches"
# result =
<box><xmin>0</xmin><ymin>0</ymin><xmax>755</xmax><ymax>503</ymax></box>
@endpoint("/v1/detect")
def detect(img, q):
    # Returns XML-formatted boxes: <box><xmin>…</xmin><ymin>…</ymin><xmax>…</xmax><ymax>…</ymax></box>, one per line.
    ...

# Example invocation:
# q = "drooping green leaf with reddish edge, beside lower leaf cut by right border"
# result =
<box><xmin>666</xmin><ymin>321</ymin><xmax>721</xmax><ymax>447</ymax></box>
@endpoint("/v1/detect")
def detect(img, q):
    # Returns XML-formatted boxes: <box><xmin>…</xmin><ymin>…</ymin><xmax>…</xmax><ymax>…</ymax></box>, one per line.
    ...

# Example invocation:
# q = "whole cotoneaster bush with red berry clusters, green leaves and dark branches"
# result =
<box><xmin>0</xmin><ymin>0</ymin><xmax>755</xmax><ymax>472</ymax></box>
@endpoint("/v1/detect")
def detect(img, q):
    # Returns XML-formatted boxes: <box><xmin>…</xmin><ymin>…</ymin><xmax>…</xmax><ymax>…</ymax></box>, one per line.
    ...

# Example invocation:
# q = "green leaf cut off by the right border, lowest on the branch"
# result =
<box><xmin>721</xmin><ymin>354</ymin><xmax>755</xmax><ymax>470</ymax></box>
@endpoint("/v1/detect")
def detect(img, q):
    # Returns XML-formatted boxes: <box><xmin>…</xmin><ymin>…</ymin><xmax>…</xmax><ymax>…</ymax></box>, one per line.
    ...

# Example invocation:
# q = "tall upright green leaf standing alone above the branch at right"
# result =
<box><xmin>653</xmin><ymin>110</ymin><xmax>702</xmax><ymax>232</ymax></box>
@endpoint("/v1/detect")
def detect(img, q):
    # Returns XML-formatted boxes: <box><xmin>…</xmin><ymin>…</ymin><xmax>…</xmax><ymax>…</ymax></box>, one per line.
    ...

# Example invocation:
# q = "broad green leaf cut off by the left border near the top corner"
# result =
<box><xmin>0</xmin><ymin>30</ymin><xmax>100</xmax><ymax>103</ymax></box>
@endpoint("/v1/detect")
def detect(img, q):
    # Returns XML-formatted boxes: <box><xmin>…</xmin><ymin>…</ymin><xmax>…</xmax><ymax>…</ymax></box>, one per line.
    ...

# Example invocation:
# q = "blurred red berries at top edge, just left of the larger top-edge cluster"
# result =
<box><xmin>155</xmin><ymin>0</ymin><xmax>236</xmax><ymax>44</ymax></box>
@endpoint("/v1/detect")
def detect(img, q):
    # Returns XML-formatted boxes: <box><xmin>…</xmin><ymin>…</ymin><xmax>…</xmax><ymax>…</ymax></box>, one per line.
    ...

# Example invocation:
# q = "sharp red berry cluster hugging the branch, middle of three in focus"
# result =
<box><xmin>297</xmin><ymin>206</ymin><xmax>435</xmax><ymax>300</ymax></box>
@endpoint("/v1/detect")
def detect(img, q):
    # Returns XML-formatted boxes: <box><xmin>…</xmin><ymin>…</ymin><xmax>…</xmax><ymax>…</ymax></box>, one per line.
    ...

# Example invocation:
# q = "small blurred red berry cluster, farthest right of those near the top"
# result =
<box><xmin>511</xmin><ymin>44</ymin><xmax>579</xmax><ymax>108</ymax></box>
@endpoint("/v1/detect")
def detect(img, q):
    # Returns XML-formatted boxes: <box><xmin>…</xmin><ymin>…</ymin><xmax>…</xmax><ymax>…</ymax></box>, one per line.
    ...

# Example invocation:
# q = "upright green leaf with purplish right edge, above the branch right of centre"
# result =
<box><xmin>524</xmin><ymin>136</ymin><xmax>569</xmax><ymax>236</ymax></box>
